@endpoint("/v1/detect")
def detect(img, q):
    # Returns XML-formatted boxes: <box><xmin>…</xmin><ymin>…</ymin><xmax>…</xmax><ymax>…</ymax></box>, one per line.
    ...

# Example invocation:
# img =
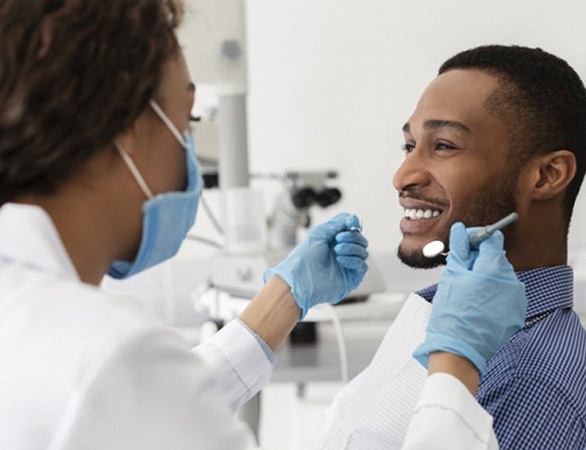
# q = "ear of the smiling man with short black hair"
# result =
<box><xmin>529</xmin><ymin>150</ymin><xmax>577</xmax><ymax>200</ymax></box>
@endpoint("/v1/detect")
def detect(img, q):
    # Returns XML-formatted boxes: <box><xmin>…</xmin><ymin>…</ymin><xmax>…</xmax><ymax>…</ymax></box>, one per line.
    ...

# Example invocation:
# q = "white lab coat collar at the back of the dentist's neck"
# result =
<box><xmin>0</xmin><ymin>203</ymin><xmax>79</xmax><ymax>280</ymax></box>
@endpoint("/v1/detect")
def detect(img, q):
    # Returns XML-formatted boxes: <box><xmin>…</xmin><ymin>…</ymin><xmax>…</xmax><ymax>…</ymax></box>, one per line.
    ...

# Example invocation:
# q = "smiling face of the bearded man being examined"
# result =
<box><xmin>393</xmin><ymin>70</ymin><xmax>517</xmax><ymax>268</ymax></box>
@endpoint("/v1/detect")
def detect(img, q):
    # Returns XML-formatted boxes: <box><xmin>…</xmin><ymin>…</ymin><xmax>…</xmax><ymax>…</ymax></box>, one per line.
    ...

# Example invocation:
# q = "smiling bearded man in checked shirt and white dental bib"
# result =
<box><xmin>320</xmin><ymin>46</ymin><xmax>586</xmax><ymax>449</ymax></box>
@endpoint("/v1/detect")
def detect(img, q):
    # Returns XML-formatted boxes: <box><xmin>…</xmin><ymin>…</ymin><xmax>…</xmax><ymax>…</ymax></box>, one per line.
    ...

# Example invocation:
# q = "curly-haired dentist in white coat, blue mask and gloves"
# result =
<box><xmin>0</xmin><ymin>0</ymin><xmax>524</xmax><ymax>449</ymax></box>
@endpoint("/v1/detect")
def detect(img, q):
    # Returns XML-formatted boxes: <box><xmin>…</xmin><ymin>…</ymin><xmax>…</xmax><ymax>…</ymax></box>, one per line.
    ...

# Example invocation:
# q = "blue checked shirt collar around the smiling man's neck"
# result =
<box><xmin>416</xmin><ymin>265</ymin><xmax>574</xmax><ymax>319</ymax></box>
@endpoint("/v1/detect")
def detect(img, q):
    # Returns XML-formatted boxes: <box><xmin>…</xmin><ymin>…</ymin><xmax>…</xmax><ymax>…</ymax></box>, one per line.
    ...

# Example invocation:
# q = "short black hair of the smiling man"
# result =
<box><xmin>439</xmin><ymin>45</ymin><xmax>586</xmax><ymax>226</ymax></box>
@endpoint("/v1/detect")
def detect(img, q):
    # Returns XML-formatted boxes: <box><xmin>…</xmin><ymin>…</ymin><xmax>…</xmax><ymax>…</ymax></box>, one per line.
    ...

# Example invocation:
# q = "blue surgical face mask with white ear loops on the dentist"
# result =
<box><xmin>108</xmin><ymin>101</ymin><xmax>203</xmax><ymax>279</ymax></box>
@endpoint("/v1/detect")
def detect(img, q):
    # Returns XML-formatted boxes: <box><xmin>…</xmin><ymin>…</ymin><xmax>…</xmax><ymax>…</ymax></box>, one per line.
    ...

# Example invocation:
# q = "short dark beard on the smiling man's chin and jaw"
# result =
<box><xmin>397</xmin><ymin>177</ymin><xmax>517</xmax><ymax>269</ymax></box>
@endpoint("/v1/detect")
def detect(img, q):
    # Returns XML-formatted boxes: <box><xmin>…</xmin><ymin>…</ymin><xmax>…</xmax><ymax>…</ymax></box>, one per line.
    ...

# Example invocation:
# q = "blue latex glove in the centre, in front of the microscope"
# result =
<box><xmin>264</xmin><ymin>213</ymin><xmax>368</xmax><ymax>319</ymax></box>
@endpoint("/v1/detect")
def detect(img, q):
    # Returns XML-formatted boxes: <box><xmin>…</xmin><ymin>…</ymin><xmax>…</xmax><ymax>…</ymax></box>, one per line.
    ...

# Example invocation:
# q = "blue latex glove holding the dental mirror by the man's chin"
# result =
<box><xmin>413</xmin><ymin>223</ymin><xmax>527</xmax><ymax>378</ymax></box>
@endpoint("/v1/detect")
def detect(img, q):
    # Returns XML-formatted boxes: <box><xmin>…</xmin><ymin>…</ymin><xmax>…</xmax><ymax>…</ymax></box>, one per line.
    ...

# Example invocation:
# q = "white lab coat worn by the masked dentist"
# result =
<box><xmin>0</xmin><ymin>204</ymin><xmax>498</xmax><ymax>449</ymax></box>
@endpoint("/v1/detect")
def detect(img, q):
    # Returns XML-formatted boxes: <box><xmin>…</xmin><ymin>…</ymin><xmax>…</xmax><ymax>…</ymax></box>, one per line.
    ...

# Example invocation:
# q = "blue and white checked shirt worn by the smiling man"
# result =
<box><xmin>418</xmin><ymin>266</ymin><xmax>586</xmax><ymax>450</ymax></box>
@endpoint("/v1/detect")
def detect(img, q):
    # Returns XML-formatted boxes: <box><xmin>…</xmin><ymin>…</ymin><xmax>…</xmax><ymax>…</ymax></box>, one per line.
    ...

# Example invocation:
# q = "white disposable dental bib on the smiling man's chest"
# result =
<box><xmin>317</xmin><ymin>293</ymin><xmax>432</xmax><ymax>450</ymax></box>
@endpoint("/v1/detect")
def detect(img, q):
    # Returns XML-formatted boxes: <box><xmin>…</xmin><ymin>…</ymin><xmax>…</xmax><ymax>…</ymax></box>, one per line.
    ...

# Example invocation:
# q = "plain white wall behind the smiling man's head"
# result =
<box><xmin>177</xmin><ymin>0</ymin><xmax>586</xmax><ymax>252</ymax></box>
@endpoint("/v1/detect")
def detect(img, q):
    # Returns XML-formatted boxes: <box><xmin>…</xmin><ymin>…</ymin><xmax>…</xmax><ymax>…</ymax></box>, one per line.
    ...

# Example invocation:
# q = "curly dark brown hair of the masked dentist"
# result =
<box><xmin>0</xmin><ymin>0</ymin><xmax>183</xmax><ymax>205</ymax></box>
